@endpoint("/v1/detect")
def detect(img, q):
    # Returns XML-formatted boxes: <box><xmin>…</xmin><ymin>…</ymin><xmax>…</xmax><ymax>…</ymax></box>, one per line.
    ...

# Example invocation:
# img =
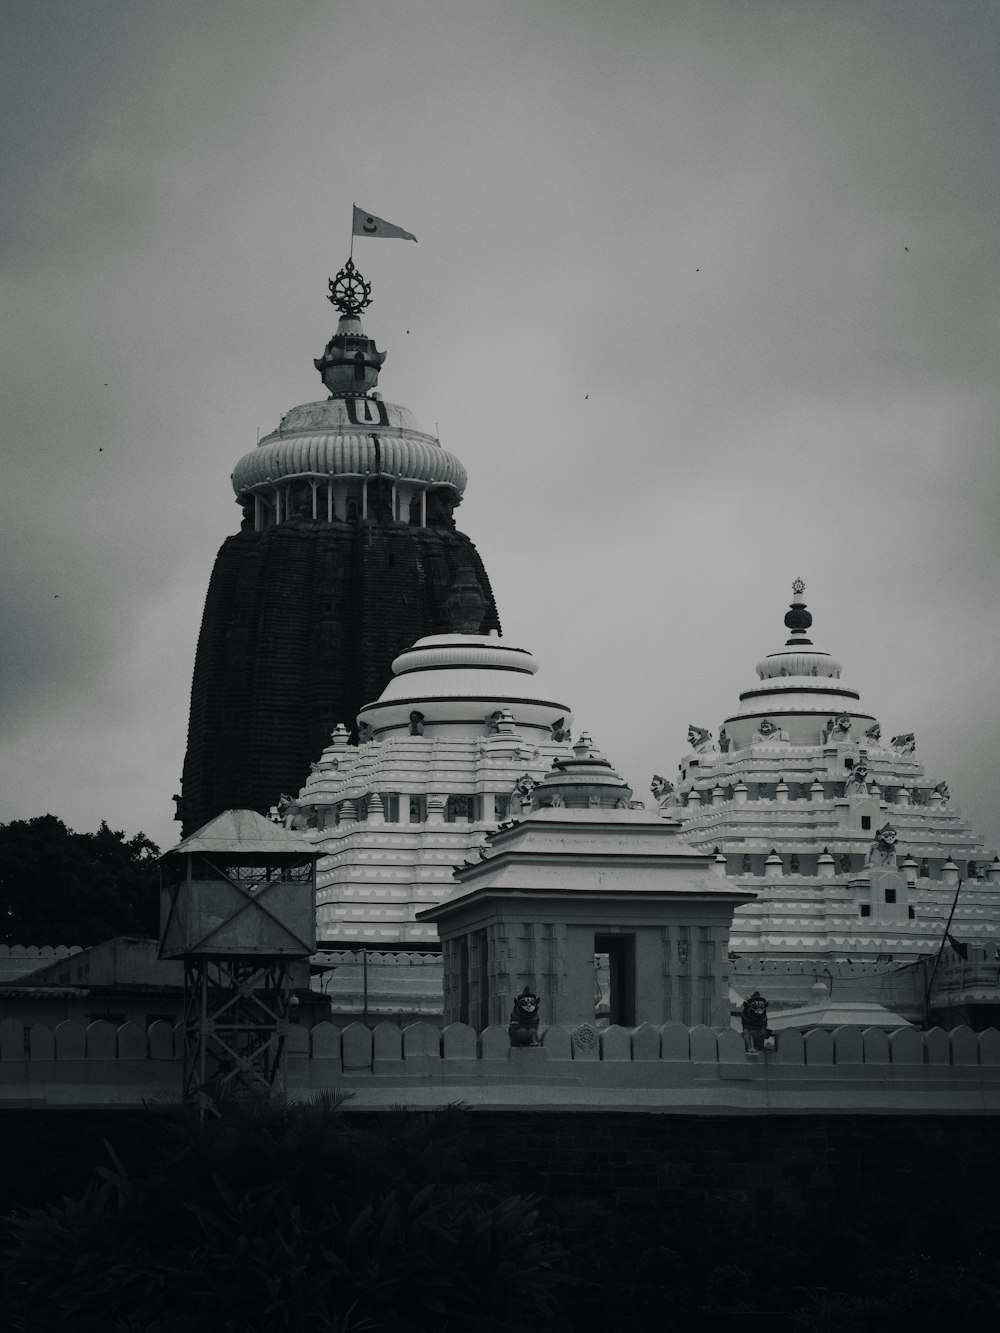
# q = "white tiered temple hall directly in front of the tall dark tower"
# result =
<box><xmin>292</xmin><ymin>635</ymin><xmax>573</xmax><ymax>949</ymax></box>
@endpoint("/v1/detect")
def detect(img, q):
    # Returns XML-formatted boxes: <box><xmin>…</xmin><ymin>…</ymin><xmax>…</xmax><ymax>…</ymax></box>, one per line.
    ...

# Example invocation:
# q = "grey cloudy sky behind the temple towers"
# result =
<box><xmin>0</xmin><ymin>0</ymin><xmax>1000</xmax><ymax>846</ymax></box>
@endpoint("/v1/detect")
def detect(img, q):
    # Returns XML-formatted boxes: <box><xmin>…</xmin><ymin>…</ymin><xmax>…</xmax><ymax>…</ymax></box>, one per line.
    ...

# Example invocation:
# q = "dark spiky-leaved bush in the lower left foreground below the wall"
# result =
<box><xmin>0</xmin><ymin>1098</ymin><xmax>561</xmax><ymax>1333</ymax></box>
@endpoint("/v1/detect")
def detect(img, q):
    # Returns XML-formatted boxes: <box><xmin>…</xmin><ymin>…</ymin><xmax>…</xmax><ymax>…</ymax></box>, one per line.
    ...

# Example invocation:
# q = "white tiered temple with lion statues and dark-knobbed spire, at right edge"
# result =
<box><xmin>666</xmin><ymin>580</ymin><xmax>1000</xmax><ymax>1025</ymax></box>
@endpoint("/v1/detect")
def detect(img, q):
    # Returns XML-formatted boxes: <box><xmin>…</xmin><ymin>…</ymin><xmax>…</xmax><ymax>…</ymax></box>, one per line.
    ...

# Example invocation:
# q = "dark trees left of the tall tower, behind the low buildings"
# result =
<box><xmin>0</xmin><ymin>814</ymin><xmax>159</xmax><ymax>946</ymax></box>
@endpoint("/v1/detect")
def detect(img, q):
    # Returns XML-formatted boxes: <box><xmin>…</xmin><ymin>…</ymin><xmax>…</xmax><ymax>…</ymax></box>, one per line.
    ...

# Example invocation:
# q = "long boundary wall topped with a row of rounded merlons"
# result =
<box><xmin>0</xmin><ymin>1018</ymin><xmax>1000</xmax><ymax>1114</ymax></box>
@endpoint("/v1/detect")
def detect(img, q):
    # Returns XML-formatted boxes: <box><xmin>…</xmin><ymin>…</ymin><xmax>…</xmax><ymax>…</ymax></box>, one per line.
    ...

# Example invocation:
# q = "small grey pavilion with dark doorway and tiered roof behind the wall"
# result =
<box><xmin>419</xmin><ymin>737</ymin><xmax>753</xmax><ymax>1029</ymax></box>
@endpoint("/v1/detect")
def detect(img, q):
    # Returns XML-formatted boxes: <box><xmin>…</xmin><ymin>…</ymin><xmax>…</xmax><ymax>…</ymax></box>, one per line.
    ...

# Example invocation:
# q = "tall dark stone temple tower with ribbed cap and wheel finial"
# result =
<box><xmin>177</xmin><ymin>260</ymin><xmax>500</xmax><ymax>836</ymax></box>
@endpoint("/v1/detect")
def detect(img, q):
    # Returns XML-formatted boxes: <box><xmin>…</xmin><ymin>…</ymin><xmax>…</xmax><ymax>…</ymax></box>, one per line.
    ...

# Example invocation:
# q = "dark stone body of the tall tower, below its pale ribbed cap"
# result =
<box><xmin>181</xmin><ymin>521</ymin><xmax>499</xmax><ymax>836</ymax></box>
